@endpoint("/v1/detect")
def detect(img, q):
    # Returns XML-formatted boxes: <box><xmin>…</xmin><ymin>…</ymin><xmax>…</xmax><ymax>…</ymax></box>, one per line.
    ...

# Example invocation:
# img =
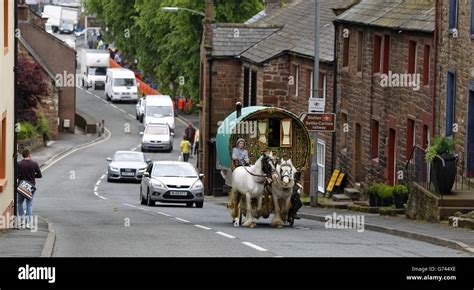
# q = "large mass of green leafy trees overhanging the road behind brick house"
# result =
<box><xmin>86</xmin><ymin>0</ymin><xmax>263</xmax><ymax>100</ymax></box>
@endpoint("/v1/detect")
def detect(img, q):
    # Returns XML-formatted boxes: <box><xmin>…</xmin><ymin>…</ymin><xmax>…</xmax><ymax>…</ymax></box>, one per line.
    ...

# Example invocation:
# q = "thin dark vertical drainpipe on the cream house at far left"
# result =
<box><xmin>12</xmin><ymin>0</ymin><xmax>18</xmax><ymax>220</ymax></box>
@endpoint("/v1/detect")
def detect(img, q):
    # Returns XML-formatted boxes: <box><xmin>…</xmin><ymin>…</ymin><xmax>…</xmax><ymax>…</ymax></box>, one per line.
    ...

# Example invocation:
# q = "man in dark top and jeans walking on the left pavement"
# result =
<box><xmin>18</xmin><ymin>149</ymin><xmax>43</xmax><ymax>228</ymax></box>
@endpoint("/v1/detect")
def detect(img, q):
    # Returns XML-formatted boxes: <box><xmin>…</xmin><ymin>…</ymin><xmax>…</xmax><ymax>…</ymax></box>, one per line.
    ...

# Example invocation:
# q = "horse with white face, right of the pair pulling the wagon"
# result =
<box><xmin>272</xmin><ymin>159</ymin><xmax>296</xmax><ymax>228</ymax></box>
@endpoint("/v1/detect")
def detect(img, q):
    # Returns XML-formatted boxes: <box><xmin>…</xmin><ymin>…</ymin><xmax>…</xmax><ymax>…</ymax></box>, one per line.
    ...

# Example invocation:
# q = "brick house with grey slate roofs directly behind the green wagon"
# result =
<box><xmin>198</xmin><ymin>0</ymin><xmax>353</xmax><ymax>194</ymax></box>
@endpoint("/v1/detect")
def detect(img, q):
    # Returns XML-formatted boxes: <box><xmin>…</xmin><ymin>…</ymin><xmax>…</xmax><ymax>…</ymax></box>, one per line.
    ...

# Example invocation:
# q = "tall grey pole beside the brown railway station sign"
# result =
<box><xmin>310</xmin><ymin>0</ymin><xmax>324</xmax><ymax>207</ymax></box>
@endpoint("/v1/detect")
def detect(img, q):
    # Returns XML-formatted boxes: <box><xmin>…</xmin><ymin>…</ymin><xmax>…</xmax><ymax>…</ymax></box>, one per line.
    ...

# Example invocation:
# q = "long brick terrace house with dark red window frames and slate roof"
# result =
<box><xmin>335</xmin><ymin>0</ymin><xmax>435</xmax><ymax>186</ymax></box>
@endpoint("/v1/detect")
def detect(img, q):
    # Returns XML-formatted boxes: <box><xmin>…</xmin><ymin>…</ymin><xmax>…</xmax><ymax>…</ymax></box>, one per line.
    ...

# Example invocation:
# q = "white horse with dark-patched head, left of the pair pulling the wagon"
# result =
<box><xmin>232</xmin><ymin>152</ymin><xmax>278</xmax><ymax>228</ymax></box>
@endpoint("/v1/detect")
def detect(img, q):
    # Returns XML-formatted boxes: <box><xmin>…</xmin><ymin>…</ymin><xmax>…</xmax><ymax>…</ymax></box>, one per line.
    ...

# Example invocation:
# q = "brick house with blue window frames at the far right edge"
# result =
<box><xmin>436</xmin><ymin>0</ymin><xmax>474</xmax><ymax>177</ymax></box>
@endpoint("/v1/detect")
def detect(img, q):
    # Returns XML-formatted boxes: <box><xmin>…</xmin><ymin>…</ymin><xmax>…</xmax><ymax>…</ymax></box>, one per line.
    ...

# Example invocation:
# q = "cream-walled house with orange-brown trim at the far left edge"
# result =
<box><xmin>0</xmin><ymin>0</ymin><xmax>15</xmax><ymax>224</ymax></box>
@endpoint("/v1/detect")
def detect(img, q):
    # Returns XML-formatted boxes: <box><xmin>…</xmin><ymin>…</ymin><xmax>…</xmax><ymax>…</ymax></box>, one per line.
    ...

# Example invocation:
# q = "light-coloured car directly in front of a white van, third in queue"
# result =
<box><xmin>140</xmin><ymin>123</ymin><xmax>174</xmax><ymax>152</ymax></box>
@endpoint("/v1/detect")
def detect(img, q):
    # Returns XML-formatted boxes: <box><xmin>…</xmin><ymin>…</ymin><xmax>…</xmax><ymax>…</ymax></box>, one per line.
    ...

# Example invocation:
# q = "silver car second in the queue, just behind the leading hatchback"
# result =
<box><xmin>107</xmin><ymin>151</ymin><xmax>151</xmax><ymax>182</ymax></box>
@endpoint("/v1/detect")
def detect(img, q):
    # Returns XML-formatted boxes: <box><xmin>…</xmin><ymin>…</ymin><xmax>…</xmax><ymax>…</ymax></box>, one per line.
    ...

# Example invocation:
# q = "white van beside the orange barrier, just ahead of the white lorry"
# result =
<box><xmin>105</xmin><ymin>68</ymin><xmax>138</xmax><ymax>102</ymax></box>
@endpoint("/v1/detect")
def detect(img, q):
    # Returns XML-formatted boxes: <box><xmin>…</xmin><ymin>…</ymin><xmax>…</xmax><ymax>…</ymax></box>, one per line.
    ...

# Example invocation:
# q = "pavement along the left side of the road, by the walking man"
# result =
<box><xmin>0</xmin><ymin>131</ymin><xmax>103</xmax><ymax>257</ymax></box>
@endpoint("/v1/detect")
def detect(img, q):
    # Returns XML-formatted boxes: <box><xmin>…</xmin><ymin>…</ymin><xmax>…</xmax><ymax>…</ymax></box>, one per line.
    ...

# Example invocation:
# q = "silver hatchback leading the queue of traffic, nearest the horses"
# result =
<box><xmin>140</xmin><ymin>161</ymin><xmax>204</xmax><ymax>208</ymax></box>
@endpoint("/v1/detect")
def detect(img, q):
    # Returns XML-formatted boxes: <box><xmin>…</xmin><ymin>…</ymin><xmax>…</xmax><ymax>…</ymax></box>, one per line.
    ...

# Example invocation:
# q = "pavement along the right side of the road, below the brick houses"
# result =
<box><xmin>206</xmin><ymin>196</ymin><xmax>474</xmax><ymax>254</ymax></box>
